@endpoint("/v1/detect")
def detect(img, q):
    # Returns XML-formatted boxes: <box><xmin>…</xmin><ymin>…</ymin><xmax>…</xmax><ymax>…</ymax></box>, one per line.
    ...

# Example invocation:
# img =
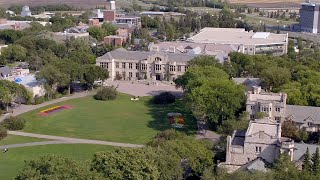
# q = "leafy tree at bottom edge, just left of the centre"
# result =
<box><xmin>91</xmin><ymin>148</ymin><xmax>159</xmax><ymax>179</ymax></box>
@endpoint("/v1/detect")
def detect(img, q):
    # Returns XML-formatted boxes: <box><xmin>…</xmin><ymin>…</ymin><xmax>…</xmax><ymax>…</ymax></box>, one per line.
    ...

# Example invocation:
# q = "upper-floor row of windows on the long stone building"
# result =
<box><xmin>100</xmin><ymin>62</ymin><xmax>188</xmax><ymax>72</ymax></box>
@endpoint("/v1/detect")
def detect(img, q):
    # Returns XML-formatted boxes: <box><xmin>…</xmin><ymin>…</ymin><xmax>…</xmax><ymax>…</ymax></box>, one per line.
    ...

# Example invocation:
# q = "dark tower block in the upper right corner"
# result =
<box><xmin>300</xmin><ymin>0</ymin><xmax>320</xmax><ymax>34</ymax></box>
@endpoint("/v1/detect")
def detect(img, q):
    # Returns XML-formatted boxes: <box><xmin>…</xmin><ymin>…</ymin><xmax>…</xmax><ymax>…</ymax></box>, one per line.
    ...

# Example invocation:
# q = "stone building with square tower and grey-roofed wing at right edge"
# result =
<box><xmin>246</xmin><ymin>86</ymin><xmax>320</xmax><ymax>132</ymax></box>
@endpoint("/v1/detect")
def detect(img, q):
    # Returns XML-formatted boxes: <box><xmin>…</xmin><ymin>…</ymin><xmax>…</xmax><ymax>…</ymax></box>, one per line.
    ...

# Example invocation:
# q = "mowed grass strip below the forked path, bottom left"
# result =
<box><xmin>0</xmin><ymin>144</ymin><xmax>114</xmax><ymax>180</ymax></box>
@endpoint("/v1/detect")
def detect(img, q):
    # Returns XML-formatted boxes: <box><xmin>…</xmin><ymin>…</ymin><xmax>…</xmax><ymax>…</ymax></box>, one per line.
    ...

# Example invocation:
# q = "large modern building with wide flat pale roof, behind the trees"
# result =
<box><xmin>187</xmin><ymin>28</ymin><xmax>288</xmax><ymax>56</ymax></box>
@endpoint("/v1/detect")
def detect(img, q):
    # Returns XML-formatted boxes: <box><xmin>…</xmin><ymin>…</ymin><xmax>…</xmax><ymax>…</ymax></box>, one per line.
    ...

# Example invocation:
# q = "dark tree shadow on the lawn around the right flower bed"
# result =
<box><xmin>145</xmin><ymin>95</ymin><xmax>197</xmax><ymax>135</ymax></box>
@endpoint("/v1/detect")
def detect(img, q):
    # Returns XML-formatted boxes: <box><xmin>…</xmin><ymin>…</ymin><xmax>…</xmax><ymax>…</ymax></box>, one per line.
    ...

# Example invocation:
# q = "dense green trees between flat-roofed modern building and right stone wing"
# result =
<box><xmin>226</xmin><ymin>42</ymin><xmax>320</xmax><ymax>106</ymax></box>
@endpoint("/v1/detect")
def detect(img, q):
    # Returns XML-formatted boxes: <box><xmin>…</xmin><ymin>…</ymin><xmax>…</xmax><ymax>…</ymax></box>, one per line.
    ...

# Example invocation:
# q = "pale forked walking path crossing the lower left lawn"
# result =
<box><xmin>0</xmin><ymin>131</ymin><xmax>144</xmax><ymax>149</ymax></box>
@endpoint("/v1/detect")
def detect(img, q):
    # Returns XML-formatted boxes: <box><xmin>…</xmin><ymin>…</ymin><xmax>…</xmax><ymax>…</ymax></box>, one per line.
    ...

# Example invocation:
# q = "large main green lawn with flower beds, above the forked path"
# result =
<box><xmin>21</xmin><ymin>94</ymin><xmax>194</xmax><ymax>144</ymax></box>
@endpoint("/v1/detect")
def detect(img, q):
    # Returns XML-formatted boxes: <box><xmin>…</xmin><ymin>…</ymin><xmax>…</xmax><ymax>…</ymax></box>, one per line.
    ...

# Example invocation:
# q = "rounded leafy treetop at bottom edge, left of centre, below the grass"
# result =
<box><xmin>16</xmin><ymin>155</ymin><xmax>102</xmax><ymax>180</ymax></box>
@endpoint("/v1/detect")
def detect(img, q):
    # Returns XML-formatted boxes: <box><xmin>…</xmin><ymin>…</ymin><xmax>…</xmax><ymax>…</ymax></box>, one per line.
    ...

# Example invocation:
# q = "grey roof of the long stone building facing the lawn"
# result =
<box><xmin>98</xmin><ymin>48</ymin><xmax>197</xmax><ymax>62</ymax></box>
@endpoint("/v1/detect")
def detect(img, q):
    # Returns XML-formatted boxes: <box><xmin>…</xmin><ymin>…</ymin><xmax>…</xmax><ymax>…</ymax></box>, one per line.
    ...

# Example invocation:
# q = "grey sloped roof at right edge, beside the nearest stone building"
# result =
<box><xmin>293</xmin><ymin>143</ymin><xmax>320</xmax><ymax>161</ymax></box>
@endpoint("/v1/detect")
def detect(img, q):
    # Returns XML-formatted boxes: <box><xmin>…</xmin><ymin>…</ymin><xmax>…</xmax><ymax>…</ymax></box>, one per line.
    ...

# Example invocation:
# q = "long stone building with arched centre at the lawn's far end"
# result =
<box><xmin>96</xmin><ymin>48</ymin><xmax>197</xmax><ymax>81</ymax></box>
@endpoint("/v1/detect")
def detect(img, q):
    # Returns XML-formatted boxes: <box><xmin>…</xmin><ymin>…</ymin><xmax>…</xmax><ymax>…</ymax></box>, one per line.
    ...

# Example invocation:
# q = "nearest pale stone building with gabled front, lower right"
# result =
<box><xmin>221</xmin><ymin>117</ymin><xmax>294</xmax><ymax>172</ymax></box>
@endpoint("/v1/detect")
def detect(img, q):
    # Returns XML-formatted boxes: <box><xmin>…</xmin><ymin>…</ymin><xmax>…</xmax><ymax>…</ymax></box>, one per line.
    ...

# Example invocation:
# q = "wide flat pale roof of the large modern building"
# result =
<box><xmin>187</xmin><ymin>28</ymin><xmax>288</xmax><ymax>45</ymax></box>
